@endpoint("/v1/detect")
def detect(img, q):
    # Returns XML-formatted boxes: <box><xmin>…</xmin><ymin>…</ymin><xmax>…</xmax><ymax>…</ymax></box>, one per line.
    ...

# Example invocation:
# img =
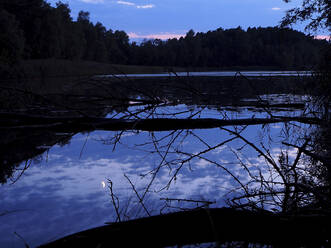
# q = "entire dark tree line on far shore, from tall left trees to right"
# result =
<box><xmin>0</xmin><ymin>0</ymin><xmax>327</xmax><ymax>68</ymax></box>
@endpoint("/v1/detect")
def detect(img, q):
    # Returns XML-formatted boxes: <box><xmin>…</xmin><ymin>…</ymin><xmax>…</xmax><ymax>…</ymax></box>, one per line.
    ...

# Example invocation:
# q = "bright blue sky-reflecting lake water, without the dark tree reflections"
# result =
<box><xmin>0</xmin><ymin>75</ymin><xmax>311</xmax><ymax>247</ymax></box>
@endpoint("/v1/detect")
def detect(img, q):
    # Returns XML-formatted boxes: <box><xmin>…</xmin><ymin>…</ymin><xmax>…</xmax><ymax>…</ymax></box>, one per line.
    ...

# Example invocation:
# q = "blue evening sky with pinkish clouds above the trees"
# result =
<box><xmin>44</xmin><ymin>0</ymin><xmax>322</xmax><ymax>39</ymax></box>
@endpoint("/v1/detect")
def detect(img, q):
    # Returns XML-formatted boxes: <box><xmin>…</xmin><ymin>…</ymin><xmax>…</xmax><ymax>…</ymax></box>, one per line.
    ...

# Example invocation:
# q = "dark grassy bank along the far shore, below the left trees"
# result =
<box><xmin>0</xmin><ymin>59</ymin><xmax>314</xmax><ymax>102</ymax></box>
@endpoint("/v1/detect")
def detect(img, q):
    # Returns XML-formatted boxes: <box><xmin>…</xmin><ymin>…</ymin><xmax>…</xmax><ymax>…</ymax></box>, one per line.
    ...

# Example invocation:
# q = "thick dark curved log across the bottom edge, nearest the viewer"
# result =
<box><xmin>40</xmin><ymin>208</ymin><xmax>331</xmax><ymax>248</ymax></box>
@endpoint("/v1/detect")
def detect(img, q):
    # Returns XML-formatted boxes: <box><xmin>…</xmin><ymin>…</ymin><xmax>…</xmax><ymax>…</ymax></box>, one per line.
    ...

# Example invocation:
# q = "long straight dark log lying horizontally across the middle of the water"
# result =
<box><xmin>0</xmin><ymin>115</ymin><xmax>321</xmax><ymax>132</ymax></box>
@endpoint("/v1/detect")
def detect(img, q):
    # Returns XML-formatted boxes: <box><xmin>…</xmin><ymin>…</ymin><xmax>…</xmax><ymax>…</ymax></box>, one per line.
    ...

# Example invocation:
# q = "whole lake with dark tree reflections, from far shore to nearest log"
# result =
<box><xmin>0</xmin><ymin>72</ymin><xmax>326</xmax><ymax>247</ymax></box>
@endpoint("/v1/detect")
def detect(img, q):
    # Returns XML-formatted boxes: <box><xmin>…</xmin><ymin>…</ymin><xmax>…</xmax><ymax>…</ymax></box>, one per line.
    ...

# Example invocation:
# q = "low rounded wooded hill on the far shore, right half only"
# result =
<box><xmin>133</xmin><ymin>27</ymin><xmax>326</xmax><ymax>68</ymax></box>
